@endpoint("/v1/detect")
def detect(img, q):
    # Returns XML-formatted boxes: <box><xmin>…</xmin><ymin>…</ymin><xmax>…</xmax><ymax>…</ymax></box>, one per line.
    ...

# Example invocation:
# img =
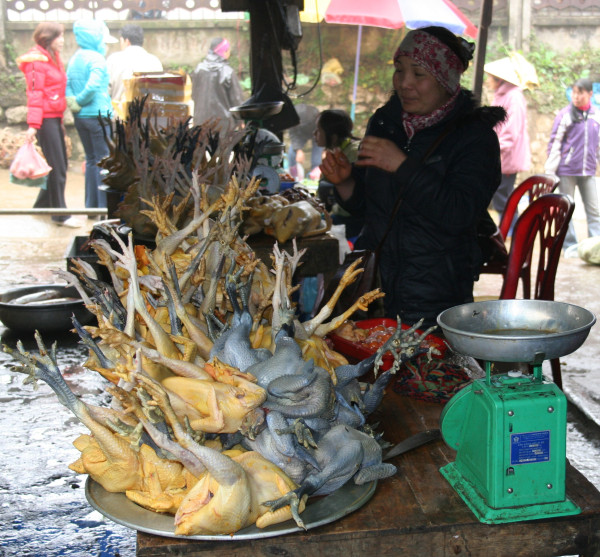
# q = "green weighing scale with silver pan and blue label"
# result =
<box><xmin>438</xmin><ymin>300</ymin><xmax>596</xmax><ymax>524</ymax></box>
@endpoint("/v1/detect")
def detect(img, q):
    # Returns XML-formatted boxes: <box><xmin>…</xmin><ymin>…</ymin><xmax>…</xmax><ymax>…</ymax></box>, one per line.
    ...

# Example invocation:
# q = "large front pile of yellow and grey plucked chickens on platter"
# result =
<box><xmin>4</xmin><ymin>116</ymin><xmax>440</xmax><ymax>535</ymax></box>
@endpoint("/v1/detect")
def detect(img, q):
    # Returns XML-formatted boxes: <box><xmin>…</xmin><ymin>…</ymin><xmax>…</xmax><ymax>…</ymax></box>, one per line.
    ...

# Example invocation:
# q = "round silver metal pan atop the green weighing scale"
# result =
<box><xmin>437</xmin><ymin>300</ymin><xmax>596</xmax><ymax>364</ymax></box>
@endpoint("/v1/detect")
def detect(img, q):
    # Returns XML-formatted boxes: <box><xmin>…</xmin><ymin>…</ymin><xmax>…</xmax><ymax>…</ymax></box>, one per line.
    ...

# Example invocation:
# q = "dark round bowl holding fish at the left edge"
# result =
<box><xmin>0</xmin><ymin>284</ymin><xmax>93</xmax><ymax>332</ymax></box>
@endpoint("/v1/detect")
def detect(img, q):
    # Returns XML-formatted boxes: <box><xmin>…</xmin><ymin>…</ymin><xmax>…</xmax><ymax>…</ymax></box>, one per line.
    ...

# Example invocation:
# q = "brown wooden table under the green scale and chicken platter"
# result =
<box><xmin>137</xmin><ymin>392</ymin><xmax>600</xmax><ymax>557</ymax></box>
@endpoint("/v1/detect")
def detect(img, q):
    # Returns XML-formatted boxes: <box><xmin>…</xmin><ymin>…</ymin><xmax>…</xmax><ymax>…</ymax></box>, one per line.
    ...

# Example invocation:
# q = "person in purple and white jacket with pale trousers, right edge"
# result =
<box><xmin>544</xmin><ymin>78</ymin><xmax>600</xmax><ymax>251</ymax></box>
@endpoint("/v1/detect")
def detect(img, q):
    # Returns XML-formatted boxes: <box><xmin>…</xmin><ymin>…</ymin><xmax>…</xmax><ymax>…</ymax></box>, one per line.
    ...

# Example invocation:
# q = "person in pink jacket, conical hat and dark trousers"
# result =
<box><xmin>485</xmin><ymin>61</ymin><xmax>531</xmax><ymax>234</ymax></box>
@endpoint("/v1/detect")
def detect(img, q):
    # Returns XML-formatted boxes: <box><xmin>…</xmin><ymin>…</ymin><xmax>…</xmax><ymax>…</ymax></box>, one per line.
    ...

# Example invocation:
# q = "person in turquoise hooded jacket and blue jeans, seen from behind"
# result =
<box><xmin>66</xmin><ymin>20</ymin><xmax>117</xmax><ymax>208</ymax></box>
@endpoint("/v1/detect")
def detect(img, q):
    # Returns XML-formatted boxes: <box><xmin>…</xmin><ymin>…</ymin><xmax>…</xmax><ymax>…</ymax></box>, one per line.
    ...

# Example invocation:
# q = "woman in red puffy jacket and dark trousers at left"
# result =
<box><xmin>17</xmin><ymin>21</ymin><xmax>81</xmax><ymax>228</ymax></box>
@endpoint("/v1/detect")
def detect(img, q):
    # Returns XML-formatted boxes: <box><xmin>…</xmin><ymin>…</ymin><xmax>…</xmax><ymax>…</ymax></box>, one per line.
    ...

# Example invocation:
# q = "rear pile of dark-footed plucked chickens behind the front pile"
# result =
<box><xmin>95</xmin><ymin>97</ymin><xmax>331</xmax><ymax>243</ymax></box>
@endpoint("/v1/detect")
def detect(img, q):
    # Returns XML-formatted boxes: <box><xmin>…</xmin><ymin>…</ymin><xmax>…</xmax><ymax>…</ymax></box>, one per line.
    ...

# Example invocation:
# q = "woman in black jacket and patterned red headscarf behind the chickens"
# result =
<box><xmin>321</xmin><ymin>27</ymin><xmax>505</xmax><ymax>327</ymax></box>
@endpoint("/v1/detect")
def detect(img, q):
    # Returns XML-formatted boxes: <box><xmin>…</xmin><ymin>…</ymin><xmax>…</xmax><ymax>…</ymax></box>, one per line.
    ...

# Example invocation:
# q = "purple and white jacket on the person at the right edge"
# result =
<box><xmin>544</xmin><ymin>104</ymin><xmax>600</xmax><ymax>176</ymax></box>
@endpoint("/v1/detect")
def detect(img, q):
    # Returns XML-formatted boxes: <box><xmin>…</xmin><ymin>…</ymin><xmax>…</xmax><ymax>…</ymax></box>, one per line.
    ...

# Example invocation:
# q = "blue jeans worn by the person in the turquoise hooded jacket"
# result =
<box><xmin>75</xmin><ymin>117</ymin><xmax>110</xmax><ymax>208</ymax></box>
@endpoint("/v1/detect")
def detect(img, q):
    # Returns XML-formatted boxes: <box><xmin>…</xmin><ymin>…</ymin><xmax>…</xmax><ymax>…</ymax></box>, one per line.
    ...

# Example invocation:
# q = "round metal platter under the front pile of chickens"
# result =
<box><xmin>85</xmin><ymin>477</ymin><xmax>377</xmax><ymax>541</ymax></box>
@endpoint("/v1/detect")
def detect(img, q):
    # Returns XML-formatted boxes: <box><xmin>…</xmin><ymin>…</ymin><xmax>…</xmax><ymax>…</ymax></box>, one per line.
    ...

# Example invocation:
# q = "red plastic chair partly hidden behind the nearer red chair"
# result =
<box><xmin>479</xmin><ymin>174</ymin><xmax>559</xmax><ymax>299</ymax></box>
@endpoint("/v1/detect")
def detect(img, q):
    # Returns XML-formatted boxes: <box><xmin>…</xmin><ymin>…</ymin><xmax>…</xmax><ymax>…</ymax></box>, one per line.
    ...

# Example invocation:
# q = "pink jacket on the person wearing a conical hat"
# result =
<box><xmin>492</xmin><ymin>81</ymin><xmax>531</xmax><ymax>174</ymax></box>
